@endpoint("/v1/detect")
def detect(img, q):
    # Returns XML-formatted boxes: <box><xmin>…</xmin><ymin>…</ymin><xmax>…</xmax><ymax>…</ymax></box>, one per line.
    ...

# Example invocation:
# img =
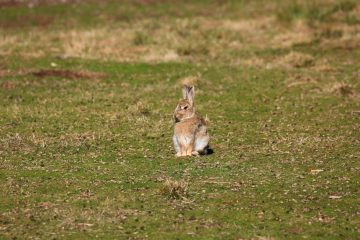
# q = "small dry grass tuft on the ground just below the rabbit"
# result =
<box><xmin>161</xmin><ymin>179</ymin><xmax>189</xmax><ymax>199</ymax></box>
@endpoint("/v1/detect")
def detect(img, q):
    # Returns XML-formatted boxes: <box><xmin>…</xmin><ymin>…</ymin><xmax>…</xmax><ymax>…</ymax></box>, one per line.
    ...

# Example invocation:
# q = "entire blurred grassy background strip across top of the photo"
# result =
<box><xmin>0</xmin><ymin>0</ymin><xmax>360</xmax><ymax>64</ymax></box>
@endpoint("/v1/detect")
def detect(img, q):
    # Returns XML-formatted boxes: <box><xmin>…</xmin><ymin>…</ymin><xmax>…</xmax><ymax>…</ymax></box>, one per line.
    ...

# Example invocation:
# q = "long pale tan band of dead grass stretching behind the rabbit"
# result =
<box><xmin>0</xmin><ymin>17</ymin><xmax>300</xmax><ymax>62</ymax></box>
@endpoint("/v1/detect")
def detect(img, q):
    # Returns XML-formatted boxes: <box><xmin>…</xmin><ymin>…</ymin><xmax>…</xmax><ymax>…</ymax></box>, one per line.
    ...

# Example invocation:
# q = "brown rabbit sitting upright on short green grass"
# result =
<box><xmin>173</xmin><ymin>85</ymin><xmax>210</xmax><ymax>157</ymax></box>
